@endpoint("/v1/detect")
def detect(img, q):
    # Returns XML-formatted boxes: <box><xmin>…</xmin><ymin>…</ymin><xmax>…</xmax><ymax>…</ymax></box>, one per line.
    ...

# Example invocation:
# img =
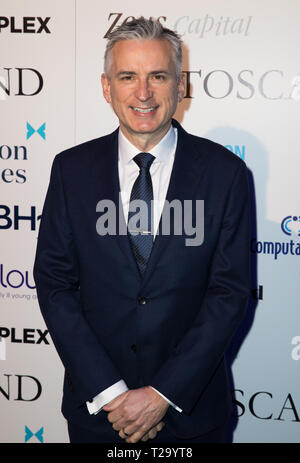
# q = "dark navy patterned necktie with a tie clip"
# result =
<box><xmin>128</xmin><ymin>153</ymin><xmax>154</xmax><ymax>275</ymax></box>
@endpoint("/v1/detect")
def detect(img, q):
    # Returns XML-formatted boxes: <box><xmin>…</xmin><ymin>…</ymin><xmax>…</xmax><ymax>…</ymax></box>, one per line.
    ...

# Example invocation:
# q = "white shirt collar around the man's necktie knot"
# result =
<box><xmin>118</xmin><ymin>125</ymin><xmax>177</xmax><ymax>165</ymax></box>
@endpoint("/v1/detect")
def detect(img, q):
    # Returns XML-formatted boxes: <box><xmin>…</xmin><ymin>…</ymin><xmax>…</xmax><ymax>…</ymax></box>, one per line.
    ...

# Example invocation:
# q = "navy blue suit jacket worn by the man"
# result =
<box><xmin>34</xmin><ymin>121</ymin><xmax>250</xmax><ymax>438</ymax></box>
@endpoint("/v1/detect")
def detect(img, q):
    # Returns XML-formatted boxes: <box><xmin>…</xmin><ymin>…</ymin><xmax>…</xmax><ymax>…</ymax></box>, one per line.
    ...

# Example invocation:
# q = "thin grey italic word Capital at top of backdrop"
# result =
<box><xmin>174</xmin><ymin>14</ymin><xmax>253</xmax><ymax>39</ymax></box>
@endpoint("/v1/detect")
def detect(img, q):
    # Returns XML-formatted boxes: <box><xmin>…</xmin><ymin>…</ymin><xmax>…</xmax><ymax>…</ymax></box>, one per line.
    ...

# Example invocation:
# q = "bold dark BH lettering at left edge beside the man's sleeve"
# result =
<box><xmin>0</xmin><ymin>204</ymin><xmax>41</xmax><ymax>231</ymax></box>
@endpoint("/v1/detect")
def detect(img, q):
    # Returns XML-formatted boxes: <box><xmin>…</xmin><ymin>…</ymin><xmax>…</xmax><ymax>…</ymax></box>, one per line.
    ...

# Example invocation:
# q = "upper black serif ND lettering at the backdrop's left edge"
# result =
<box><xmin>0</xmin><ymin>68</ymin><xmax>44</xmax><ymax>100</ymax></box>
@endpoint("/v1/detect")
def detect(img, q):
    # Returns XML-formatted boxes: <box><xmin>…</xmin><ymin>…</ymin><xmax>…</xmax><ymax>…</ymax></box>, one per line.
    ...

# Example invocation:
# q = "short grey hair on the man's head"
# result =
<box><xmin>104</xmin><ymin>16</ymin><xmax>182</xmax><ymax>79</ymax></box>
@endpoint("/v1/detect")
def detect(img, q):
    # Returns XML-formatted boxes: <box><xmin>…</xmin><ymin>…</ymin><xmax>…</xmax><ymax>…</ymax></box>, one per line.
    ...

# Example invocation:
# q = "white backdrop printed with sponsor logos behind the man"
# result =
<box><xmin>0</xmin><ymin>0</ymin><xmax>300</xmax><ymax>443</ymax></box>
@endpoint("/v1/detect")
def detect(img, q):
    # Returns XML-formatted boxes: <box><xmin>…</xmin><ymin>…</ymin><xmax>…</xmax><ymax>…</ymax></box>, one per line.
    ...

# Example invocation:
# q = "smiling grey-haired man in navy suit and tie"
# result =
<box><xmin>34</xmin><ymin>18</ymin><xmax>249</xmax><ymax>442</ymax></box>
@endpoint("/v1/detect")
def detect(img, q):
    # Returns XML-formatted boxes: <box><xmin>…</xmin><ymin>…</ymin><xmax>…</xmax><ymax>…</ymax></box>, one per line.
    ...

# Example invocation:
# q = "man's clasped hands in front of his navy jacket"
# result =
<box><xmin>103</xmin><ymin>386</ymin><xmax>169</xmax><ymax>443</ymax></box>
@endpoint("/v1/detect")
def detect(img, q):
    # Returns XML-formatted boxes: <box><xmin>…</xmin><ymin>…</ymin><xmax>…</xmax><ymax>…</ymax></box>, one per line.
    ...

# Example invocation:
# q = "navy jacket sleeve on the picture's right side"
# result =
<box><xmin>151</xmin><ymin>162</ymin><xmax>250</xmax><ymax>414</ymax></box>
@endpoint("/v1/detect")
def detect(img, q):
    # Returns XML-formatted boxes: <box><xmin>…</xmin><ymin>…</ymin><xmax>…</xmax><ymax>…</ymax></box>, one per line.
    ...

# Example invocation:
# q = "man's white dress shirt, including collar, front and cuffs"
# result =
<box><xmin>87</xmin><ymin>126</ymin><xmax>182</xmax><ymax>414</ymax></box>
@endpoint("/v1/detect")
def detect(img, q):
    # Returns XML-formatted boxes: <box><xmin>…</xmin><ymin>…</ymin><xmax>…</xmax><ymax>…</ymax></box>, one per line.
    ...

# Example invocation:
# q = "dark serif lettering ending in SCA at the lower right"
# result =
<box><xmin>233</xmin><ymin>389</ymin><xmax>300</xmax><ymax>423</ymax></box>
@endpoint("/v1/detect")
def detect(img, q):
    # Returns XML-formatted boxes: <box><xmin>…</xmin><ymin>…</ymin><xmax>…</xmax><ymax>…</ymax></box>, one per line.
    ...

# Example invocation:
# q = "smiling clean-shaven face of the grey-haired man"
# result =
<box><xmin>102</xmin><ymin>40</ymin><xmax>184</xmax><ymax>147</ymax></box>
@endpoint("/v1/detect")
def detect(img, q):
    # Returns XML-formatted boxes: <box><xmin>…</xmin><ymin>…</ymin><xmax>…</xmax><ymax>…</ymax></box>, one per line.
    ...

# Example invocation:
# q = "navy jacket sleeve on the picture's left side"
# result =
<box><xmin>34</xmin><ymin>155</ymin><xmax>121</xmax><ymax>404</ymax></box>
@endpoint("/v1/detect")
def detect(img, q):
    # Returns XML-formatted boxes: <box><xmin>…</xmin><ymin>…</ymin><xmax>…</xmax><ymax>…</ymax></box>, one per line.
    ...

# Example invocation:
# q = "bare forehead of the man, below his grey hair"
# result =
<box><xmin>112</xmin><ymin>39</ymin><xmax>175</xmax><ymax>71</ymax></box>
